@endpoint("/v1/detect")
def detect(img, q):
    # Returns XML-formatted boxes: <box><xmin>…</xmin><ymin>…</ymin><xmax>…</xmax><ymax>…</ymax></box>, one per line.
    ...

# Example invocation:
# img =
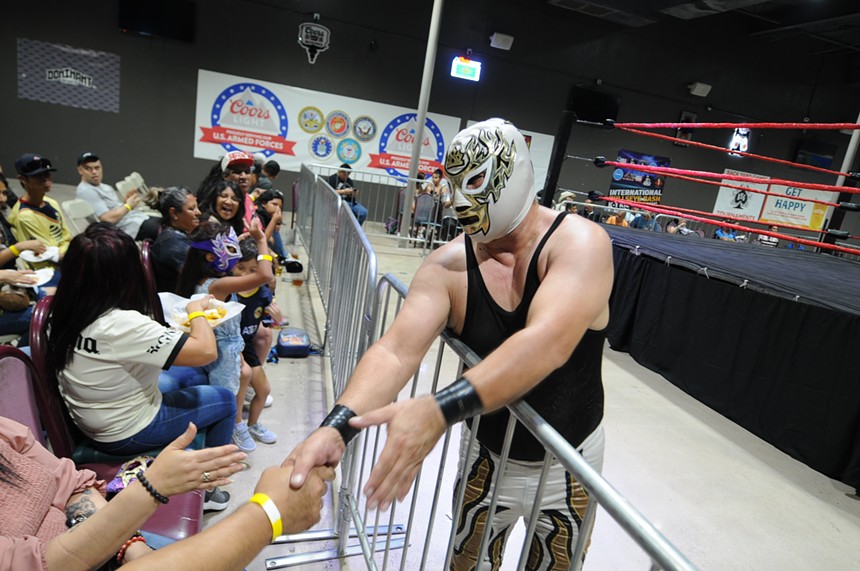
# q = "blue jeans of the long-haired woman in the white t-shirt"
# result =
<box><xmin>93</xmin><ymin>385</ymin><xmax>236</xmax><ymax>455</ymax></box>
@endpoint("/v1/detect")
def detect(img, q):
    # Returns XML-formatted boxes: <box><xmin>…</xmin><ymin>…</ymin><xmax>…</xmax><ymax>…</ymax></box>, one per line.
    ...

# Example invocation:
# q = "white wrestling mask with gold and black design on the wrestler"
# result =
<box><xmin>445</xmin><ymin>119</ymin><xmax>534</xmax><ymax>242</ymax></box>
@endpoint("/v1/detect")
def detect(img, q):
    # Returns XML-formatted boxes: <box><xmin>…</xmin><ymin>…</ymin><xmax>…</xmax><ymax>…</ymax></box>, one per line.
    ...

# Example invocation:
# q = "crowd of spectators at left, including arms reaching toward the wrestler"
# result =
<box><xmin>0</xmin><ymin>151</ymin><xmax>326</xmax><ymax>570</ymax></box>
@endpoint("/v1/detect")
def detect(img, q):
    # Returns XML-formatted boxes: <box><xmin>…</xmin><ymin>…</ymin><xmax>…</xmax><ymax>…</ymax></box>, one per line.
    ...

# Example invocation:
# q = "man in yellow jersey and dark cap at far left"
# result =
<box><xmin>9</xmin><ymin>153</ymin><xmax>72</xmax><ymax>287</ymax></box>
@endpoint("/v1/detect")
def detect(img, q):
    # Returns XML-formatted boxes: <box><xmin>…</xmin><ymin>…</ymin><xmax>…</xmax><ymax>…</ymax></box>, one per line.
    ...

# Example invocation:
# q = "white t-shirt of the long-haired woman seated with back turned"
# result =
<box><xmin>59</xmin><ymin>309</ymin><xmax>187</xmax><ymax>442</ymax></box>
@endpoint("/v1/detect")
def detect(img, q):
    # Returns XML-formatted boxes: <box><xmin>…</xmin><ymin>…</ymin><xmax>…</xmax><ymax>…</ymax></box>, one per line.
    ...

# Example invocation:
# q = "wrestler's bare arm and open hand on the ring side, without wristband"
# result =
<box><xmin>350</xmin><ymin>214</ymin><xmax>613</xmax><ymax>509</ymax></box>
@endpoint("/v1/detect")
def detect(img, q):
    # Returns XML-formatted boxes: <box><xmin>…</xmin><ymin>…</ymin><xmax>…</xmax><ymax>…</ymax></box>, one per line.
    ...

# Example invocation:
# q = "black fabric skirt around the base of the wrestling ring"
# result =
<box><xmin>608</xmin><ymin>246</ymin><xmax>860</xmax><ymax>488</ymax></box>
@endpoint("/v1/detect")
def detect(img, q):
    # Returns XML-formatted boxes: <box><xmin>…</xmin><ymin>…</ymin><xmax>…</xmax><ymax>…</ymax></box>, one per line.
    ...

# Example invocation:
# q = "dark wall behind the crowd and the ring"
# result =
<box><xmin>5</xmin><ymin>0</ymin><xmax>860</xmax><ymax>237</ymax></box>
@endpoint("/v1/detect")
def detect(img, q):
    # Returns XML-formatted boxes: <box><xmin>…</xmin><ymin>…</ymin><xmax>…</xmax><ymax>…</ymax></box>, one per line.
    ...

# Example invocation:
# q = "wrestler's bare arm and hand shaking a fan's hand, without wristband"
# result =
<box><xmin>285</xmin><ymin>248</ymin><xmax>462</xmax><ymax>488</ymax></box>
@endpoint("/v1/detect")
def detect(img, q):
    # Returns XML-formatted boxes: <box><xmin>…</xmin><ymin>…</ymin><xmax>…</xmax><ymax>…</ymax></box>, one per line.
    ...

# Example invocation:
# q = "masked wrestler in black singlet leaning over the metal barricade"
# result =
<box><xmin>288</xmin><ymin>119</ymin><xmax>612</xmax><ymax>569</ymax></box>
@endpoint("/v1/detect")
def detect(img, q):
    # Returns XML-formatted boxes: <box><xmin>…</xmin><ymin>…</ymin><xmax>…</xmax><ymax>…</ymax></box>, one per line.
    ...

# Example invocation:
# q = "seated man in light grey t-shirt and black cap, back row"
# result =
<box><xmin>75</xmin><ymin>152</ymin><xmax>159</xmax><ymax>240</ymax></box>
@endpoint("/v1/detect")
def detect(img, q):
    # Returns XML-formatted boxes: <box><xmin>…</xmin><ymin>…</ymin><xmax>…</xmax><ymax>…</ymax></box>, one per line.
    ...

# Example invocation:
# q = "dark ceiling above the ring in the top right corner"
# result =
<box><xmin>547</xmin><ymin>0</ymin><xmax>860</xmax><ymax>55</ymax></box>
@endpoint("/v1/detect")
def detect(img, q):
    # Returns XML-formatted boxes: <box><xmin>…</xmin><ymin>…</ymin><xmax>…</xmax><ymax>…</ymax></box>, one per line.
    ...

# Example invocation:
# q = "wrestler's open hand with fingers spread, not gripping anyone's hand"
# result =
<box><xmin>349</xmin><ymin>395</ymin><xmax>447</xmax><ymax>510</ymax></box>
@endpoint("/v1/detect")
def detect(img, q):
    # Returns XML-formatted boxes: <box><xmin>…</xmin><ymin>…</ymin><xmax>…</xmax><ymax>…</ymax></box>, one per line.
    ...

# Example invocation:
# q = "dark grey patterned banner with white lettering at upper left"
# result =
<box><xmin>18</xmin><ymin>38</ymin><xmax>120</xmax><ymax>113</ymax></box>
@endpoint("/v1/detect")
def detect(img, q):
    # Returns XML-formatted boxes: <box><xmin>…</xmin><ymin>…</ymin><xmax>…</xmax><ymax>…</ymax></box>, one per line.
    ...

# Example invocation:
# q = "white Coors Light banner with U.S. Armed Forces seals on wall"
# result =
<box><xmin>194</xmin><ymin>69</ymin><xmax>460</xmax><ymax>177</ymax></box>
